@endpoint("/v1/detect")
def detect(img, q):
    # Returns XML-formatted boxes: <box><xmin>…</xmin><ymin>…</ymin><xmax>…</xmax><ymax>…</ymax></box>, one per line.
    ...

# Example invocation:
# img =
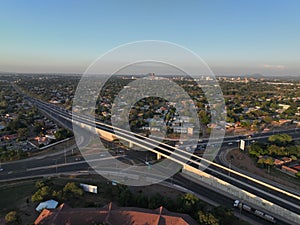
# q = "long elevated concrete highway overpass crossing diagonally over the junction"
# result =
<box><xmin>22</xmin><ymin>94</ymin><xmax>300</xmax><ymax>224</ymax></box>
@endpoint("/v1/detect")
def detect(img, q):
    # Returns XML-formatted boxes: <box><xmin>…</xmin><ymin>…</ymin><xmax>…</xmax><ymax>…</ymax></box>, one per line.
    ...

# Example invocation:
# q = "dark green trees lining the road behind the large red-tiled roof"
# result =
<box><xmin>106</xmin><ymin>185</ymin><xmax>246</xmax><ymax>225</ymax></box>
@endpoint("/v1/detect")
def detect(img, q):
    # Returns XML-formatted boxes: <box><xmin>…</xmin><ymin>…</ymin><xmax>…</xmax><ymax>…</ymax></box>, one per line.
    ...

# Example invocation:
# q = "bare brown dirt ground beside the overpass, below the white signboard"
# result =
<box><xmin>226</xmin><ymin>149</ymin><xmax>300</xmax><ymax>190</ymax></box>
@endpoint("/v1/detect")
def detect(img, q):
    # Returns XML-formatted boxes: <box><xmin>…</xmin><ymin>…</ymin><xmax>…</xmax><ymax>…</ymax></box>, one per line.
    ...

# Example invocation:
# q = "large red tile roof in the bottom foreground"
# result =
<box><xmin>34</xmin><ymin>203</ymin><xmax>197</xmax><ymax>225</ymax></box>
